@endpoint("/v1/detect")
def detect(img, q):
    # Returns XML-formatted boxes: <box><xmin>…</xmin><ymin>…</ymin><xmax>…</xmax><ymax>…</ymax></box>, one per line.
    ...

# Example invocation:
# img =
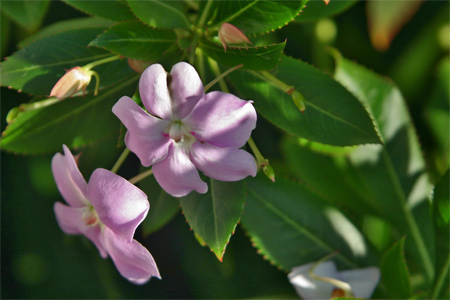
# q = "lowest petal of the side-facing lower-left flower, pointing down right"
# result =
<box><xmin>103</xmin><ymin>228</ymin><xmax>161</xmax><ymax>284</ymax></box>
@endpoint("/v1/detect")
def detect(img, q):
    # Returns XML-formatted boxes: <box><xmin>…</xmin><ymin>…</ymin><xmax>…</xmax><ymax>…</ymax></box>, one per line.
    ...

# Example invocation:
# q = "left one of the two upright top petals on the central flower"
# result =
<box><xmin>139</xmin><ymin>64</ymin><xmax>172</xmax><ymax>120</ymax></box>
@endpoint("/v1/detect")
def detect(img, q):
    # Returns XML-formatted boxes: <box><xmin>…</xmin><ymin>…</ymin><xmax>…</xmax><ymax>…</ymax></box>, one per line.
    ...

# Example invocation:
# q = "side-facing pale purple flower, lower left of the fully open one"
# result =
<box><xmin>52</xmin><ymin>145</ymin><xmax>160</xmax><ymax>284</ymax></box>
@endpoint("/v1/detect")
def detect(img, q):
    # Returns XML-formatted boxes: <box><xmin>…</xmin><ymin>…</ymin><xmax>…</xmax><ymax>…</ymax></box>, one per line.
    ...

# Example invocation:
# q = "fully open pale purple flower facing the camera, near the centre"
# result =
<box><xmin>113</xmin><ymin>62</ymin><xmax>257</xmax><ymax>197</ymax></box>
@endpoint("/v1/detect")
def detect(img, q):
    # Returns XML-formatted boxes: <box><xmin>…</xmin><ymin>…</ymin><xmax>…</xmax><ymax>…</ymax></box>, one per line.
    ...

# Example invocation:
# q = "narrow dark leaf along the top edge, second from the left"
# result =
<box><xmin>63</xmin><ymin>0</ymin><xmax>134</xmax><ymax>21</ymax></box>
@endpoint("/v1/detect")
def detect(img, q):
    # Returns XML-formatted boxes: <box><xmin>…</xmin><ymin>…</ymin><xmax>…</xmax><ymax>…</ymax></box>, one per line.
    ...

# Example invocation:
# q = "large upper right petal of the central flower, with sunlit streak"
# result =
<box><xmin>184</xmin><ymin>91</ymin><xmax>256</xmax><ymax>148</ymax></box>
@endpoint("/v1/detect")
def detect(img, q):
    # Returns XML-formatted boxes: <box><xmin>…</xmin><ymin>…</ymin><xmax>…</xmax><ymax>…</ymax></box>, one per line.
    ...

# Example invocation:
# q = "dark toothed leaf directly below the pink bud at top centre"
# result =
<box><xmin>200</xmin><ymin>40</ymin><xmax>286</xmax><ymax>71</ymax></box>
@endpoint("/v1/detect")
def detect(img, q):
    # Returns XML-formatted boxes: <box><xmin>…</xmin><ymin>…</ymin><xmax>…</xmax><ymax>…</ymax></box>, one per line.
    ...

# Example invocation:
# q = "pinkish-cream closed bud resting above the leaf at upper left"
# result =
<box><xmin>50</xmin><ymin>67</ymin><xmax>92</xmax><ymax>100</ymax></box>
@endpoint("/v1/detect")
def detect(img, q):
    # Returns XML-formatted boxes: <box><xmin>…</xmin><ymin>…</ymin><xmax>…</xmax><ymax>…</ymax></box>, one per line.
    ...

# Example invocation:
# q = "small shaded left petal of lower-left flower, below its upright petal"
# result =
<box><xmin>53</xmin><ymin>202</ymin><xmax>108</xmax><ymax>258</ymax></box>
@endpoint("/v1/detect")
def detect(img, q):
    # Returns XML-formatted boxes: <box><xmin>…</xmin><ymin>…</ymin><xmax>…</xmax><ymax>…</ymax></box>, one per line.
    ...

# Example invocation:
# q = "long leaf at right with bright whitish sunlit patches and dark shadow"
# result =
<box><xmin>335</xmin><ymin>55</ymin><xmax>434</xmax><ymax>280</ymax></box>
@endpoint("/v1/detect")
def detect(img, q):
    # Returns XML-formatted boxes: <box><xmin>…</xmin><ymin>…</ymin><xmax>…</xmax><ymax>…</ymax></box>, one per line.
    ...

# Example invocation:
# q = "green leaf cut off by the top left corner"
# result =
<box><xmin>1</xmin><ymin>0</ymin><xmax>50</xmax><ymax>32</ymax></box>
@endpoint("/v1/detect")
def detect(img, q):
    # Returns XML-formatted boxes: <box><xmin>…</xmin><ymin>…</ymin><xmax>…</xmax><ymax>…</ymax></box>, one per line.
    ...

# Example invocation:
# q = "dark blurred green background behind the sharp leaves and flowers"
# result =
<box><xmin>1</xmin><ymin>0</ymin><xmax>449</xmax><ymax>299</ymax></box>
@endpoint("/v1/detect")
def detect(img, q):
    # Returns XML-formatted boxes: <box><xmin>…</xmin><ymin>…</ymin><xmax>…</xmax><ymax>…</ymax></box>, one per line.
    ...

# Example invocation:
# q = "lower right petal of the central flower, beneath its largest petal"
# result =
<box><xmin>190</xmin><ymin>142</ymin><xmax>257</xmax><ymax>181</ymax></box>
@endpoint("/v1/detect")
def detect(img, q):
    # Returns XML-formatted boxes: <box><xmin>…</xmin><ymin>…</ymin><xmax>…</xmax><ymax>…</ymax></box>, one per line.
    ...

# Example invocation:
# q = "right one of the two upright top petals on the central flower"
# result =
<box><xmin>170</xmin><ymin>62</ymin><xmax>205</xmax><ymax>120</ymax></box>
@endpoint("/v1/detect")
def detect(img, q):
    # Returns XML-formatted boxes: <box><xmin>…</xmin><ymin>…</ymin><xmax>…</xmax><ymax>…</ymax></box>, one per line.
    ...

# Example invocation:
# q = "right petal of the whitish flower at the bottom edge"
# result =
<box><xmin>339</xmin><ymin>267</ymin><xmax>380</xmax><ymax>299</ymax></box>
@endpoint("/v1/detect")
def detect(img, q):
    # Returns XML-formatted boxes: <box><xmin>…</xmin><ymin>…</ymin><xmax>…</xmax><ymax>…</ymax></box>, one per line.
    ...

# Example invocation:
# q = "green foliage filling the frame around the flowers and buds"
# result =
<box><xmin>0</xmin><ymin>0</ymin><xmax>450</xmax><ymax>299</ymax></box>
